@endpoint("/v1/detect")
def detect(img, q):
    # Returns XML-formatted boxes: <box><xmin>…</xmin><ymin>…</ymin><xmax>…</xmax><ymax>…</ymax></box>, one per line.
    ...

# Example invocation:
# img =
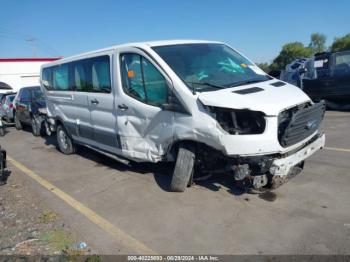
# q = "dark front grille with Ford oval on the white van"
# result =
<box><xmin>278</xmin><ymin>101</ymin><xmax>326</xmax><ymax>147</ymax></box>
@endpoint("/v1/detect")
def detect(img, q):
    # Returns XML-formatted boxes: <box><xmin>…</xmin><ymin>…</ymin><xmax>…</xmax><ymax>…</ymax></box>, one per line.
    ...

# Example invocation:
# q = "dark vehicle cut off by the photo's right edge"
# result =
<box><xmin>302</xmin><ymin>51</ymin><xmax>350</xmax><ymax>109</ymax></box>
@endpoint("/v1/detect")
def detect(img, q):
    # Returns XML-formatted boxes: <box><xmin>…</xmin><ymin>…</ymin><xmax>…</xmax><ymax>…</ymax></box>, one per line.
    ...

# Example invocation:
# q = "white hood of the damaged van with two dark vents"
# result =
<box><xmin>198</xmin><ymin>79</ymin><xmax>310</xmax><ymax>116</ymax></box>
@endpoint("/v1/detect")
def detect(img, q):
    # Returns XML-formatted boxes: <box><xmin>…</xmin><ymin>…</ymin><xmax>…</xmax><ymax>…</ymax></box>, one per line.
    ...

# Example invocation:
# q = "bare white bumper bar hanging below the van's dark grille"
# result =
<box><xmin>270</xmin><ymin>133</ymin><xmax>326</xmax><ymax>176</ymax></box>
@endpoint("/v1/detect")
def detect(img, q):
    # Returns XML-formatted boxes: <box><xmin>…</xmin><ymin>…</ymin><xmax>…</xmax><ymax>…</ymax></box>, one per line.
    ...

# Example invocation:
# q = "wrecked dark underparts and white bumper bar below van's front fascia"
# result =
<box><xmin>197</xmin><ymin>133</ymin><xmax>325</xmax><ymax>192</ymax></box>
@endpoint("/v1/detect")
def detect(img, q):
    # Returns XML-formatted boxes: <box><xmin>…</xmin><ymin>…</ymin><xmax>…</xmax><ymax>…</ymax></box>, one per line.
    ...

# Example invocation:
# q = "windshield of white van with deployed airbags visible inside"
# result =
<box><xmin>153</xmin><ymin>43</ymin><xmax>271</xmax><ymax>91</ymax></box>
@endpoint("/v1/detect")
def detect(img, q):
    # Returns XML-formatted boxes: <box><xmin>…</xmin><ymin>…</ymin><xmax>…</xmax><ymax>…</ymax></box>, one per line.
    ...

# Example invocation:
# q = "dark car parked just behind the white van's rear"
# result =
<box><xmin>13</xmin><ymin>86</ymin><xmax>46</xmax><ymax>136</ymax></box>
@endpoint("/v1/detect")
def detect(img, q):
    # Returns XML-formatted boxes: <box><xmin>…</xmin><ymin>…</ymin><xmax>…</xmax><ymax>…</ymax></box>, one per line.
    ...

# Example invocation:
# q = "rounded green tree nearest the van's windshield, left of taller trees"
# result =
<box><xmin>270</xmin><ymin>42</ymin><xmax>313</xmax><ymax>70</ymax></box>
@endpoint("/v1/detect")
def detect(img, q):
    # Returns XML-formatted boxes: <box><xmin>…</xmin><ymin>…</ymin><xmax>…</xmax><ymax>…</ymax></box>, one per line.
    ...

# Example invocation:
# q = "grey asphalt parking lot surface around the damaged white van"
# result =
<box><xmin>0</xmin><ymin>111</ymin><xmax>350</xmax><ymax>254</ymax></box>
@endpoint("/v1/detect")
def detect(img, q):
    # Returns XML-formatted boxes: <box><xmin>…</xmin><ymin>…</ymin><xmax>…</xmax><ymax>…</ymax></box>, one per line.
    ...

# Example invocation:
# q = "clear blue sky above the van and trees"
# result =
<box><xmin>0</xmin><ymin>0</ymin><xmax>350</xmax><ymax>62</ymax></box>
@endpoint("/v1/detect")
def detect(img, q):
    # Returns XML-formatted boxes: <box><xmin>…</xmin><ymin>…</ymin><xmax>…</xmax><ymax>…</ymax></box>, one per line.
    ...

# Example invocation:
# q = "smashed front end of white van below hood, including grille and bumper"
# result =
<box><xmin>191</xmin><ymin>102</ymin><xmax>325</xmax><ymax>191</ymax></box>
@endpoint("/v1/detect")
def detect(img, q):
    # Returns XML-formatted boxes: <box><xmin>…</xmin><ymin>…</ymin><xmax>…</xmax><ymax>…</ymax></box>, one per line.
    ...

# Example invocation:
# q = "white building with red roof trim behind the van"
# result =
<box><xmin>0</xmin><ymin>57</ymin><xmax>61</xmax><ymax>94</ymax></box>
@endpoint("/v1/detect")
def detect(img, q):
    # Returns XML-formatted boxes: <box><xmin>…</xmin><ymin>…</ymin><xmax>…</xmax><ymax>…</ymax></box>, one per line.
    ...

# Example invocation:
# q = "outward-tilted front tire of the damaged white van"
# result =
<box><xmin>170</xmin><ymin>144</ymin><xmax>195</xmax><ymax>192</ymax></box>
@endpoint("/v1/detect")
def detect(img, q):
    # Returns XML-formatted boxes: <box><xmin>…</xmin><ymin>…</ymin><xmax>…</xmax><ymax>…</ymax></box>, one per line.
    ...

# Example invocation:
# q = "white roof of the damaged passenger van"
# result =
<box><xmin>42</xmin><ymin>40</ymin><xmax>222</xmax><ymax>67</ymax></box>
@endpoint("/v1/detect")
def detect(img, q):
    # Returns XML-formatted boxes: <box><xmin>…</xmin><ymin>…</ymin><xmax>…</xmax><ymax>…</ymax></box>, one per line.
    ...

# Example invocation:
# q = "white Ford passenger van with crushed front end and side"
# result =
<box><xmin>41</xmin><ymin>41</ymin><xmax>325</xmax><ymax>191</ymax></box>
